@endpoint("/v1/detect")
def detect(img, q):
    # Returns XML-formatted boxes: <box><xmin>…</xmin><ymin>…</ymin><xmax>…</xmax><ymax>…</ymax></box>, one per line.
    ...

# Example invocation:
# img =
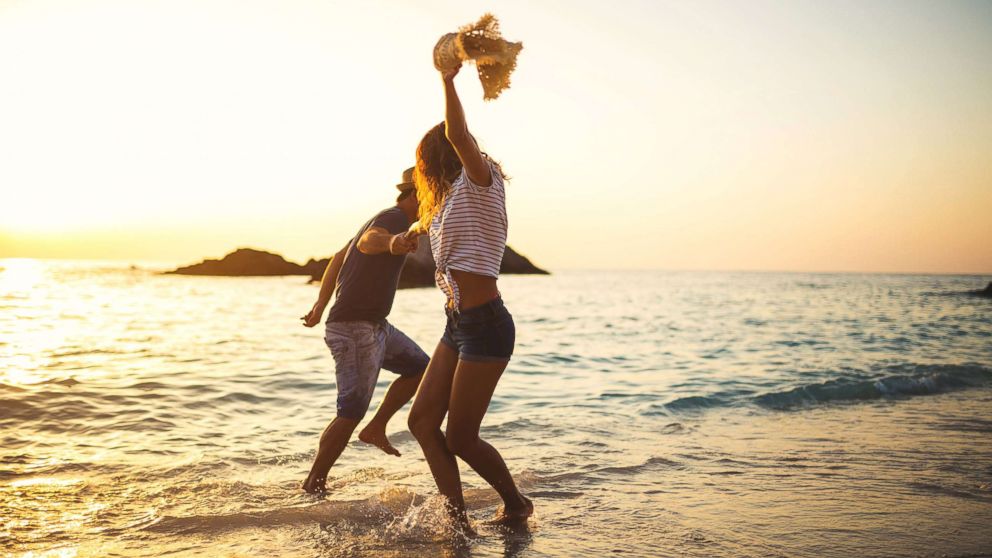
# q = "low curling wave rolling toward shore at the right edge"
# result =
<box><xmin>652</xmin><ymin>365</ymin><xmax>992</xmax><ymax>414</ymax></box>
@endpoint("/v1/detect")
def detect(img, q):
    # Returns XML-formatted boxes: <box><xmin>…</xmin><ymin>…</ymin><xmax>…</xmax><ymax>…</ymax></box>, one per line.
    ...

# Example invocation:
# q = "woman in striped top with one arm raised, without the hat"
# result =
<box><xmin>409</xmin><ymin>63</ymin><xmax>534</xmax><ymax>528</ymax></box>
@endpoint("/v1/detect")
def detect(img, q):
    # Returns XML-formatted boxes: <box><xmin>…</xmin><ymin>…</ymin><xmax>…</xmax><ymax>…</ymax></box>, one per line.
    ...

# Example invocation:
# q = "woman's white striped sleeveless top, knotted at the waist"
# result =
<box><xmin>429</xmin><ymin>161</ymin><xmax>507</xmax><ymax>308</ymax></box>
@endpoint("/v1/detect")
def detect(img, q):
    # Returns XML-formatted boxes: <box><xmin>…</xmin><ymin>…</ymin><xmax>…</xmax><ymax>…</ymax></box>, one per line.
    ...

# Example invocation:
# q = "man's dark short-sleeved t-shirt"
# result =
<box><xmin>327</xmin><ymin>207</ymin><xmax>410</xmax><ymax>322</ymax></box>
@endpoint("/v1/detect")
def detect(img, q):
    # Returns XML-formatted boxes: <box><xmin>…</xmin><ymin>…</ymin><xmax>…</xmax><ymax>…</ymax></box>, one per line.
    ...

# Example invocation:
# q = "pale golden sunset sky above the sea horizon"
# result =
<box><xmin>0</xmin><ymin>0</ymin><xmax>992</xmax><ymax>273</ymax></box>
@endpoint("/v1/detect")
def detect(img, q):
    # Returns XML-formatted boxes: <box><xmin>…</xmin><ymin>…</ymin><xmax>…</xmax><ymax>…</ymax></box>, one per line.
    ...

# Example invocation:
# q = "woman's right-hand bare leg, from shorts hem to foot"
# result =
<box><xmin>445</xmin><ymin>360</ymin><xmax>534</xmax><ymax>520</ymax></box>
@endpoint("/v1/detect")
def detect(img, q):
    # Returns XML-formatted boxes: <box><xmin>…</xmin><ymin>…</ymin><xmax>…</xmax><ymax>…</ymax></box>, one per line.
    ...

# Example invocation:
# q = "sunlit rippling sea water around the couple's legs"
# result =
<box><xmin>0</xmin><ymin>260</ymin><xmax>992</xmax><ymax>557</ymax></box>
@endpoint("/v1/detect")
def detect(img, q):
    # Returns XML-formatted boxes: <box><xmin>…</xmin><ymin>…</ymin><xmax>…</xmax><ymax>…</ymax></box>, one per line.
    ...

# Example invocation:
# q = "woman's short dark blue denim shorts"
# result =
<box><xmin>441</xmin><ymin>298</ymin><xmax>517</xmax><ymax>362</ymax></box>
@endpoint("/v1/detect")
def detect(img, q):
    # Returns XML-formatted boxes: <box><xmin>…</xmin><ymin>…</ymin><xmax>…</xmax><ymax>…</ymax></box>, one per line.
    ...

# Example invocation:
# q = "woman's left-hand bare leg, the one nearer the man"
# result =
<box><xmin>407</xmin><ymin>343</ymin><xmax>468</xmax><ymax>526</ymax></box>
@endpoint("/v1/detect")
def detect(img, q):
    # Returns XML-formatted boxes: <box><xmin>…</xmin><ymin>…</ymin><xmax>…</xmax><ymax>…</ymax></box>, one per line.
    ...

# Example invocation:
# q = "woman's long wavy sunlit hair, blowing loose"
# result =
<box><xmin>413</xmin><ymin>122</ymin><xmax>505</xmax><ymax>231</ymax></box>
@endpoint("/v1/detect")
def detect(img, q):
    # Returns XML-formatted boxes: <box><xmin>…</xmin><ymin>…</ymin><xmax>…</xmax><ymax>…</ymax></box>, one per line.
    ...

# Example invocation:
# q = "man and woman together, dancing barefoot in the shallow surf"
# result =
<box><xmin>303</xmin><ymin>64</ymin><xmax>534</xmax><ymax>527</ymax></box>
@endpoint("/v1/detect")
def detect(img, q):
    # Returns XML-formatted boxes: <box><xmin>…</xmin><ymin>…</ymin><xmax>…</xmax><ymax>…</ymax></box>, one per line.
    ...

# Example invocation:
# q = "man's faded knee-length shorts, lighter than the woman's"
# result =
<box><xmin>324</xmin><ymin>320</ymin><xmax>430</xmax><ymax>420</ymax></box>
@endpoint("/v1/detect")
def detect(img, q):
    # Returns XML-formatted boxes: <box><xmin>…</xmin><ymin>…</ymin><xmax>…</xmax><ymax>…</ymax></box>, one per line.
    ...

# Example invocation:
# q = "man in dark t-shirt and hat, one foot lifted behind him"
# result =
<box><xmin>301</xmin><ymin>168</ymin><xmax>429</xmax><ymax>494</ymax></box>
